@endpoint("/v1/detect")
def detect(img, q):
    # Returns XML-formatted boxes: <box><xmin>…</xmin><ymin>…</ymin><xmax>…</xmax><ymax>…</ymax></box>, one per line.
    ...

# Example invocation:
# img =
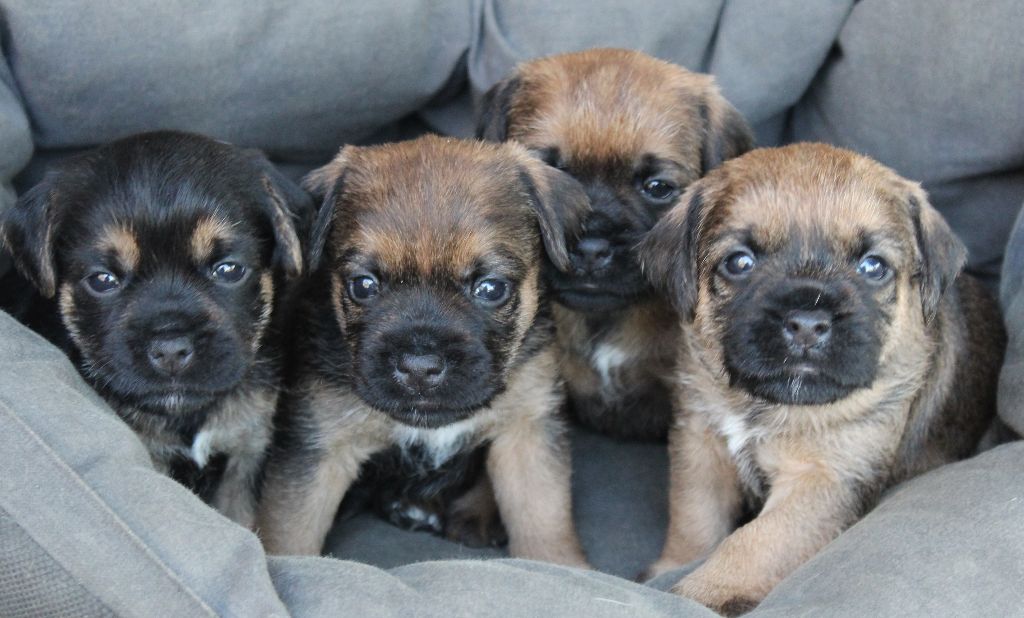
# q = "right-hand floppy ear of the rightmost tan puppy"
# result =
<box><xmin>908</xmin><ymin>183</ymin><xmax>967</xmax><ymax>322</ymax></box>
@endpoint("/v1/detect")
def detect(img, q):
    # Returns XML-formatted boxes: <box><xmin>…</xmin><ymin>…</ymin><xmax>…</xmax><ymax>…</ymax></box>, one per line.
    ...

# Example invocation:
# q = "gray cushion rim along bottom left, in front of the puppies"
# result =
<box><xmin>0</xmin><ymin>312</ymin><xmax>712</xmax><ymax>616</ymax></box>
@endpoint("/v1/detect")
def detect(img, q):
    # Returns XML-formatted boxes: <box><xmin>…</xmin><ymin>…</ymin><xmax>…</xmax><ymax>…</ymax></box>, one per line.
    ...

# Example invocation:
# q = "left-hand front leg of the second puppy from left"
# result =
<box><xmin>257</xmin><ymin>449</ymin><xmax>365</xmax><ymax>556</ymax></box>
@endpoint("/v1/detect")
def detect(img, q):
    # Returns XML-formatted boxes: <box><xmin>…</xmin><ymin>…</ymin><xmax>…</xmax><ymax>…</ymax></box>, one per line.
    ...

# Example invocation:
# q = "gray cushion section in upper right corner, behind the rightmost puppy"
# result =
<box><xmin>787</xmin><ymin>0</ymin><xmax>1024</xmax><ymax>283</ymax></box>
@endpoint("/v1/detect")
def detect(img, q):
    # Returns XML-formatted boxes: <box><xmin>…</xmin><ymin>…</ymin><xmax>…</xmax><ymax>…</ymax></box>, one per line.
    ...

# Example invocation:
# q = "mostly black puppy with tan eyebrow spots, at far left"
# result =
<box><xmin>2</xmin><ymin>132</ymin><xmax>313</xmax><ymax>526</ymax></box>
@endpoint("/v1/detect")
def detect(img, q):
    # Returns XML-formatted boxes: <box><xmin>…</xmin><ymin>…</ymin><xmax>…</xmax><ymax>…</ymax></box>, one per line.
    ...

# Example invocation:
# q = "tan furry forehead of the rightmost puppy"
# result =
<box><xmin>710</xmin><ymin>148</ymin><xmax>912</xmax><ymax>252</ymax></box>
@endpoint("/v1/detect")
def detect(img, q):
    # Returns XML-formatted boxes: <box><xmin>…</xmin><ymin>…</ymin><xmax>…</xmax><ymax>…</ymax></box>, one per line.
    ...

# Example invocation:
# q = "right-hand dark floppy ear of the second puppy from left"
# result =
<box><xmin>521</xmin><ymin>153</ymin><xmax>590</xmax><ymax>271</ymax></box>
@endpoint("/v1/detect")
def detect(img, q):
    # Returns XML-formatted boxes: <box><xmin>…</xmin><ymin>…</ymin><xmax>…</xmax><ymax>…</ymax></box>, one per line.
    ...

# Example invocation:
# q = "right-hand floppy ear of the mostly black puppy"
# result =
<box><xmin>245</xmin><ymin>151</ymin><xmax>315</xmax><ymax>278</ymax></box>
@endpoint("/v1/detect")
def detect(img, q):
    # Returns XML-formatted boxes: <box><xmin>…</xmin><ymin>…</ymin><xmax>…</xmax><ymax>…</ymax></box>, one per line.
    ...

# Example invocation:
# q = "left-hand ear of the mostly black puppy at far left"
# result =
<box><xmin>0</xmin><ymin>172</ymin><xmax>66</xmax><ymax>298</ymax></box>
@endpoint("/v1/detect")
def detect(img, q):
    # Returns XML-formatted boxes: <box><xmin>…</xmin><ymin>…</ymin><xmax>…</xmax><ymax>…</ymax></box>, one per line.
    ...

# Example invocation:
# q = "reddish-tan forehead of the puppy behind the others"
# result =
<box><xmin>510</xmin><ymin>49</ymin><xmax>711</xmax><ymax>159</ymax></box>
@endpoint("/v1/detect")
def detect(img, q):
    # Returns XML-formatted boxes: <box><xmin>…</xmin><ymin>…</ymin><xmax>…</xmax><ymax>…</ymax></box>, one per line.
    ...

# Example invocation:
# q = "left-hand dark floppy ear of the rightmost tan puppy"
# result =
<box><xmin>637</xmin><ymin>180</ymin><xmax>705</xmax><ymax>320</ymax></box>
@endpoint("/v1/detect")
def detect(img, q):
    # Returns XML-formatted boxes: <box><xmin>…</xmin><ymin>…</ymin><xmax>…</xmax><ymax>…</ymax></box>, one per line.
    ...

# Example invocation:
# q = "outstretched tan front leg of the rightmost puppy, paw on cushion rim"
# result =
<box><xmin>673</xmin><ymin>460</ymin><xmax>858</xmax><ymax>615</ymax></box>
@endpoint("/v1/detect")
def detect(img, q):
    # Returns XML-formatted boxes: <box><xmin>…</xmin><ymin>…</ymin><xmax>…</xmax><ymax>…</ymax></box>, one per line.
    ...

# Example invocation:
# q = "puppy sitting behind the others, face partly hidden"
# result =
<box><xmin>479</xmin><ymin>49</ymin><xmax>753</xmax><ymax>439</ymax></box>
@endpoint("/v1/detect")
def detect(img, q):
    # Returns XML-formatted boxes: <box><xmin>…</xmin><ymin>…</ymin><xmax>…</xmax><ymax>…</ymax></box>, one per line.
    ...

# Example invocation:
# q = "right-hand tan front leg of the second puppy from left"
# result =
<box><xmin>487</xmin><ymin>415</ymin><xmax>589</xmax><ymax>568</ymax></box>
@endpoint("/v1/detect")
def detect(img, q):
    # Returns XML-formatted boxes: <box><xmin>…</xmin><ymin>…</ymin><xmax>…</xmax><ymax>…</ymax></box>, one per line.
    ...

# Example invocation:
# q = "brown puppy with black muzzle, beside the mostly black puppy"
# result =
<box><xmin>258</xmin><ymin>136</ymin><xmax>587</xmax><ymax>566</ymax></box>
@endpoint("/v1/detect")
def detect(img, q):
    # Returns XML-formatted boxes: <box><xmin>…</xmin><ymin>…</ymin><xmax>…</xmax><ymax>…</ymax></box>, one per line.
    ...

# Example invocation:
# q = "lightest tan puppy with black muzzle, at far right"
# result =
<box><xmin>640</xmin><ymin>144</ymin><xmax>1005</xmax><ymax>614</ymax></box>
